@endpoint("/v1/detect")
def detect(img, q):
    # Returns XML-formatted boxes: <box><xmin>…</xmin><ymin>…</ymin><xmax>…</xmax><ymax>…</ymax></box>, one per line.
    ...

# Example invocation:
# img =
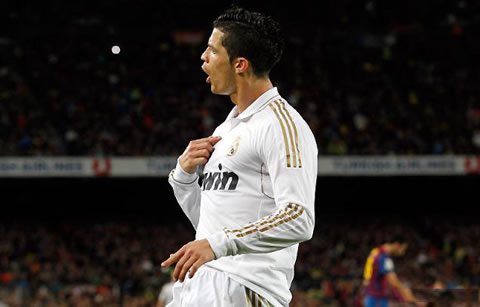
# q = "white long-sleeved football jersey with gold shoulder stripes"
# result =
<box><xmin>169</xmin><ymin>88</ymin><xmax>318</xmax><ymax>306</ymax></box>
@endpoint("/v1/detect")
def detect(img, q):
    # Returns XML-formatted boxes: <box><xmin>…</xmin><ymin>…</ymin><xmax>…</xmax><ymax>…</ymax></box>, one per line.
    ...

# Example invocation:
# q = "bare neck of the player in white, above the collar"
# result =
<box><xmin>230</xmin><ymin>78</ymin><xmax>273</xmax><ymax>113</ymax></box>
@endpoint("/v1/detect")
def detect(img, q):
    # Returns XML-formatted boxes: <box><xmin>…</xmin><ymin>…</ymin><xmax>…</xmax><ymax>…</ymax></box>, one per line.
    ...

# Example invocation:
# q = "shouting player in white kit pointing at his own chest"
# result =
<box><xmin>162</xmin><ymin>8</ymin><xmax>317</xmax><ymax>307</ymax></box>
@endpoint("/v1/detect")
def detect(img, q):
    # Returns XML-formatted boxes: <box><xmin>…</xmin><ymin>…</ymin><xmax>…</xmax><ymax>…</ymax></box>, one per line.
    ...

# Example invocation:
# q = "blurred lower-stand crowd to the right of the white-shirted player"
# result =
<box><xmin>292</xmin><ymin>219</ymin><xmax>480</xmax><ymax>307</ymax></box>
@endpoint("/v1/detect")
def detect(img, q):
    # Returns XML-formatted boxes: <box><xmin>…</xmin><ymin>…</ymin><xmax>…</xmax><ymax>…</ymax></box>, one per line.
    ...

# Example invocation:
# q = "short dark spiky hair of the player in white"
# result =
<box><xmin>213</xmin><ymin>7</ymin><xmax>284</xmax><ymax>77</ymax></box>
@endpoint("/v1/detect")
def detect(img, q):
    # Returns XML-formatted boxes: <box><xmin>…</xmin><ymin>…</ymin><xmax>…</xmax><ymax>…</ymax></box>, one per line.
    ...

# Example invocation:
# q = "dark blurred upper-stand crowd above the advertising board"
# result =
<box><xmin>0</xmin><ymin>0</ymin><xmax>480</xmax><ymax>156</ymax></box>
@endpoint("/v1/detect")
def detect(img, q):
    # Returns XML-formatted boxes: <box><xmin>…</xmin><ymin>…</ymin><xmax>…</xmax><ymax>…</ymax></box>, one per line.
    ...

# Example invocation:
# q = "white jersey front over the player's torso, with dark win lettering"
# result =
<box><xmin>200</xmin><ymin>114</ymin><xmax>275</xmax><ymax>232</ymax></box>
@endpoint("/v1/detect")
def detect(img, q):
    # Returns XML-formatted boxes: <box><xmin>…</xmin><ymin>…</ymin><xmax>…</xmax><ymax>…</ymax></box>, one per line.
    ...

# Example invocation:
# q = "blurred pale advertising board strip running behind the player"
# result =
<box><xmin>0</xmin><ymin>156</ymin><xmax>480</xmax><ymax>177</ymax></box>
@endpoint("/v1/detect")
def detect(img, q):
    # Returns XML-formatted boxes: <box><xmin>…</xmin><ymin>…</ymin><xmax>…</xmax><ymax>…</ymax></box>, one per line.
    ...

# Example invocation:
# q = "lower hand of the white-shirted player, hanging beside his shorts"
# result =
<box><xmin>162</xmin><ymin>239</ymin><xmax>215</xmax><ymax>282</ymax></box>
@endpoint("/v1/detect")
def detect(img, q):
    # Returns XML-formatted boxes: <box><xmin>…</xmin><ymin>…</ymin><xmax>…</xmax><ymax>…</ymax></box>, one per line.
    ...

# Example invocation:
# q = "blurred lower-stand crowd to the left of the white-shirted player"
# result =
<box><xmin>0</xmin><ymin>223</ymin><xmax>193</xmax><ymax>307</ymax></box>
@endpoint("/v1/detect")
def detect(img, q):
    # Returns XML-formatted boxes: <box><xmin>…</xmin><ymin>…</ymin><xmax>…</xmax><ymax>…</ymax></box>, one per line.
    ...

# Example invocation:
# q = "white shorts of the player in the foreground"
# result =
<box><xmin>167</xmin><ymin>267</ymin><xmax>273</xmax><ymax>307</ymax></box>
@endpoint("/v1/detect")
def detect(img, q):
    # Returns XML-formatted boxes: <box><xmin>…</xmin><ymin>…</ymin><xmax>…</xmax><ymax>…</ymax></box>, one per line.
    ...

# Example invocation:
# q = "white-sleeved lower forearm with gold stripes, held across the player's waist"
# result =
<box><xmin>207</xmin><ymin>204</ymin><xmax>314</xmax><ymax>258</ymax></box>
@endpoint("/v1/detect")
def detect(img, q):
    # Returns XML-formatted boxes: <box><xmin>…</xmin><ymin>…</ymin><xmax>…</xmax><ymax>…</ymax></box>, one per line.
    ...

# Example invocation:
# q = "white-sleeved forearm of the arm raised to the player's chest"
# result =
<box><xmin>168</xmin><ymin>164</ymin><xmax>201</xmax><ymax>229</ymax></box>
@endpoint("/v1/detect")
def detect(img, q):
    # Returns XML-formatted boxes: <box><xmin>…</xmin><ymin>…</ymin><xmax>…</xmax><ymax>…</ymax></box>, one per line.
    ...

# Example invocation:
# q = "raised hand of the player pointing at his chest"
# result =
<box><xmin>179</xmin><ymin>136</ymin><xmax>221</xmax><ymax>174</ymax></box>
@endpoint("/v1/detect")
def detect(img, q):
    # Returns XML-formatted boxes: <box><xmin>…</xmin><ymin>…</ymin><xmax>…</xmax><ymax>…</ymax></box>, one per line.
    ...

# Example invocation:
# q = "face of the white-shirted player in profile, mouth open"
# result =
<box><xmin>201</xmin><ymin>28</ymin><xmax>235</xmax><ymax>95</ymax></box>
